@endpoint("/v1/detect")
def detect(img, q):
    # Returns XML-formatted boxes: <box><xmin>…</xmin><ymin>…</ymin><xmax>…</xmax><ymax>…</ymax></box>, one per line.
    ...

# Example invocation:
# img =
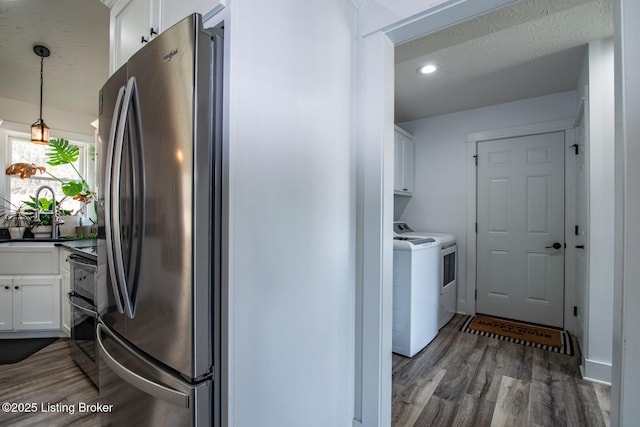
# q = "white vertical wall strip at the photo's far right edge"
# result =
<box><xmin>611</xmin><ymin>0</ymin><xmax>640</xmax><ymax>427</ymax></box>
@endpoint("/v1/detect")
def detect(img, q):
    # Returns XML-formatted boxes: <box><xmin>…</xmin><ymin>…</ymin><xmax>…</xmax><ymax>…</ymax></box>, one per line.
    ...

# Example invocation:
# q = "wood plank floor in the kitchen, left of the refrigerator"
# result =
<box><xmin>0</xmin><ymin>338</ymin><xmax>100</xmax><ymax>427</ymax></box>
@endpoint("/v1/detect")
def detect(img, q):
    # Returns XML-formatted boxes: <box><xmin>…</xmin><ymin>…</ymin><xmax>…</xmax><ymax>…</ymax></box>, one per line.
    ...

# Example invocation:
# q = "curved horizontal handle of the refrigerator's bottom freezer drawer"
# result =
<box><xmin>96</xmin><ymin>323</ymin><xmax>189</xmax><ymax>408</ymax></box>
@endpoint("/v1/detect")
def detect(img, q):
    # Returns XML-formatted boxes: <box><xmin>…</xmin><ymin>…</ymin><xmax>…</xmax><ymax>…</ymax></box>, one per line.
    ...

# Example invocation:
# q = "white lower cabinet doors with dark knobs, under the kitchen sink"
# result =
<box><xmin>0</xmin><ymin>276</ymin><xmax>60</xmax><ymax>331</ymax></box>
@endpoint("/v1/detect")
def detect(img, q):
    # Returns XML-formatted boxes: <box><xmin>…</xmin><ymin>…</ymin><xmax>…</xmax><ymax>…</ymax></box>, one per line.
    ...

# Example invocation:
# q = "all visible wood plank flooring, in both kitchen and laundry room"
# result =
<box><xmin>0</xmin><ymin>316</ymin><xmax>610</xmax><ymax>427</ymax></box>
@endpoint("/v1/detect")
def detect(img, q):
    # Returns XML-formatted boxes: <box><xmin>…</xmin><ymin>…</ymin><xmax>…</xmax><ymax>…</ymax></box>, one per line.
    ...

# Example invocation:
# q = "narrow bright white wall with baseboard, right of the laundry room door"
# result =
<box><xmin>582</xmin><ymin>39</ymin><xmax>615</xmax><ymax>383</ymax></box>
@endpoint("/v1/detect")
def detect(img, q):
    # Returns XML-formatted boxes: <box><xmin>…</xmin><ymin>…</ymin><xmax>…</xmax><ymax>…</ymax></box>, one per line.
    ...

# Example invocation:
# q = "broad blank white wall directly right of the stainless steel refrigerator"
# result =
<box><xmin>225</xmin><ymin>0</ymin><xmax>356</xmax><ymax>427</ymax></box>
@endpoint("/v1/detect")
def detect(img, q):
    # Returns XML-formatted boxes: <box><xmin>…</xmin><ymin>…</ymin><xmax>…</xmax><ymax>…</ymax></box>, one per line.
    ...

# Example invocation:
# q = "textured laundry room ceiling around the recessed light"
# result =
<box><xmin>395</xmin><ymin>0</ymin><xmax>613</xmax><ymax>122</ymax></box>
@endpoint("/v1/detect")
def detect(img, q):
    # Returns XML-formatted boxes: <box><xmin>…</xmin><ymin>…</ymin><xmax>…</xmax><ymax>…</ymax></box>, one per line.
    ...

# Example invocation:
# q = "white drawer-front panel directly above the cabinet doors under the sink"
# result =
<box><xmin>0</xmin><ymin>245</ymin><xmax>60</xmax><ymax>275</ymax></box>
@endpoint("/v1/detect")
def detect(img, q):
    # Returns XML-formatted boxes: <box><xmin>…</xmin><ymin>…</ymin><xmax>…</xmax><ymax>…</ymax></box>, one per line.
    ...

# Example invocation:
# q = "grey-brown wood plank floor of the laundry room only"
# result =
<box><xmin>391</xmin><ymin>316</ymin><xmax>610</xmax><ymax>427</ymax></box>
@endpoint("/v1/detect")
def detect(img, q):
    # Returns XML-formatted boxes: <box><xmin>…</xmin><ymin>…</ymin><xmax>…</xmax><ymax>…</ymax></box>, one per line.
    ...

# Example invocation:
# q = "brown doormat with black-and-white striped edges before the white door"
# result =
<box><xmin>460</xmin><ymin>314</ymin><xmax>573</xmax><ymax>356</ymax></box>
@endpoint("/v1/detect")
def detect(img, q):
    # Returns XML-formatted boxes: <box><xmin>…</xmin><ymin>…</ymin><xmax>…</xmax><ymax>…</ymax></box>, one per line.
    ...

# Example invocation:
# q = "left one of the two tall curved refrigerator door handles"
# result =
<box><xmin>104</xmin><ymin>86</ymin><xmax>125</xmax><ymax>314</ymax></box>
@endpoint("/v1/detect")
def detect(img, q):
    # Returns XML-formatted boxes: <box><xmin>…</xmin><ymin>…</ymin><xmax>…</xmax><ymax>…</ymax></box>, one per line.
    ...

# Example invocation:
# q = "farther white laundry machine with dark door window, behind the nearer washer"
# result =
<box><xmin>393</xmin><ymin>221</ymin><xmax>458</xmax><ymax>329</ymax></box>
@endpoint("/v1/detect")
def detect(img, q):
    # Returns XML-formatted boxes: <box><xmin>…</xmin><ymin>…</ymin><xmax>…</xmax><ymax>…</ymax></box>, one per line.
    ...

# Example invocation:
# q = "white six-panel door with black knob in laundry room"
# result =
<box><xmin>476</xmin><ymin>132</ymin><xmax>564</xmax><ymax>327</ymax></box>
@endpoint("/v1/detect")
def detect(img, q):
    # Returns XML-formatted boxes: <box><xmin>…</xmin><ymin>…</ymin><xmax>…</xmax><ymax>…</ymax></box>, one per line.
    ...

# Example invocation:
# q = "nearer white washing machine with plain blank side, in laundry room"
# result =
<box><xmin>392</xmin><ymin>236</ymin><xmax>440</xmax><ymax>357</ymax></box>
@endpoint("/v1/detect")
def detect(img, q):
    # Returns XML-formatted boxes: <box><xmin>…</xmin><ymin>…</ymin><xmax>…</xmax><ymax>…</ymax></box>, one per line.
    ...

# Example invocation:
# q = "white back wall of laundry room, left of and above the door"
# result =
<box><xmin>396</xmin><ymin>91</ymin><xmax>576</xmax><ymax>313</ymax></box>
